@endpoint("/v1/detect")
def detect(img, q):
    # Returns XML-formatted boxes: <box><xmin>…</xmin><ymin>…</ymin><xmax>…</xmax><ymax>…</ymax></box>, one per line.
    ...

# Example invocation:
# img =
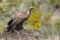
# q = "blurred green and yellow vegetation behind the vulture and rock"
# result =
<box><xmin>0</xmin><ymin>0</ymin><xmax>60</xmax><ymax>35</ymax></box>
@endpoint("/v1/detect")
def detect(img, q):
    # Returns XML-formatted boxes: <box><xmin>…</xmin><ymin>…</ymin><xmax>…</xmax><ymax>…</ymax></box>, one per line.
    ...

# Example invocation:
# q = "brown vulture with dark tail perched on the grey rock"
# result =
<box><xmin>5</xmin><ymin>7</ymin><xmax>33</xmax><ymax>32</ymax></box>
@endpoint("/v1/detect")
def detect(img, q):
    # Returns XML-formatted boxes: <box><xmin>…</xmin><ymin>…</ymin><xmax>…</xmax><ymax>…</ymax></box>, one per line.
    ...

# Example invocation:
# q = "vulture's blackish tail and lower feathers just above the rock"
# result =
<box><xmin>5</xmin><ymin>20</ymin><xmax>23</xmax><ymax>32</ymax></box>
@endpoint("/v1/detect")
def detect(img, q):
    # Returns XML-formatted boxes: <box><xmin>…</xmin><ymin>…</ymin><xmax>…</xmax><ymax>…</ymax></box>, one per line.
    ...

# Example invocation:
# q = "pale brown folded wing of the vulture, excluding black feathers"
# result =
<box><xmin>13</xmin><ymin>12</ymin><xmax>28</xmax><ymax>24</ymax></box>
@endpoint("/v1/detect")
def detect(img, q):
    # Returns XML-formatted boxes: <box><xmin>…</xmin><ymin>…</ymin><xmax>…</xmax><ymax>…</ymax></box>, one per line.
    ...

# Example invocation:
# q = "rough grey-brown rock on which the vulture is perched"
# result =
<box><xmin>0</xmin><ymin>29</ymin><xmax>44</xmax><ymax>40</ymax></box>
